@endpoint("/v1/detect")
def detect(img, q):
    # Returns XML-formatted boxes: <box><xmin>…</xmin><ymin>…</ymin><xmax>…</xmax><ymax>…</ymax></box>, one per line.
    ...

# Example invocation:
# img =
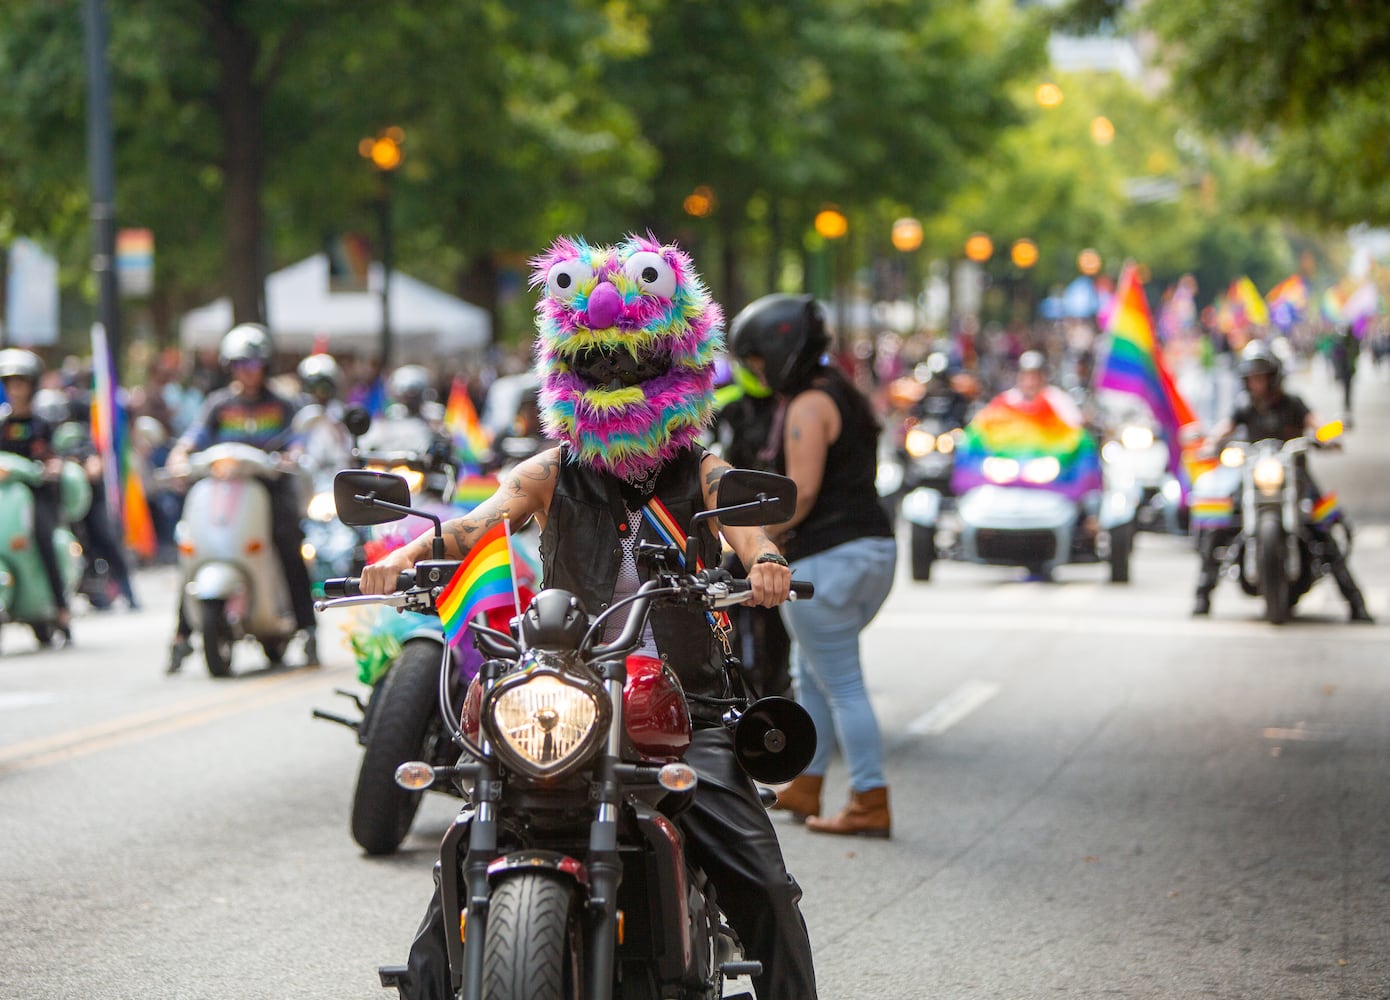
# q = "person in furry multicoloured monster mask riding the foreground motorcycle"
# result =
<box><xmin>361</xmin><ymin>238</ymin><xmax>816</xmax><ymax>1000</ymax></box>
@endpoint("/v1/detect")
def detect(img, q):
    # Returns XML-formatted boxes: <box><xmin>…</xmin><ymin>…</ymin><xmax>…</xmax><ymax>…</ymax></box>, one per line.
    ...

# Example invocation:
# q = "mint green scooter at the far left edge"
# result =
<box><xmin>0</xmin><ymin>452</ymin><xmax>92</xmax><ymax>645</ymax></box>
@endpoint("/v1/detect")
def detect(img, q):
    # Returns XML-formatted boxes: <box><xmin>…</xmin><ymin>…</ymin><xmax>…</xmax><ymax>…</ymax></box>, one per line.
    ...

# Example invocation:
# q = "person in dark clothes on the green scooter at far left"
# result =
<box><xmin>0</xmin><ymin>348</ymin><xmax>72</xmax><ymax>643</ymax></box>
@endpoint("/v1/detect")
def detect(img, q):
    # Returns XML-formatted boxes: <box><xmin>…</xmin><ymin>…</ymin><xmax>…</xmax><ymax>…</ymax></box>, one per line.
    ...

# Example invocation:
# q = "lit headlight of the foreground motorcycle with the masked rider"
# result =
<box><xmin>482</xmin><ymin>663</ymin><xmax>612</xmax><ymax>777</ymax></box>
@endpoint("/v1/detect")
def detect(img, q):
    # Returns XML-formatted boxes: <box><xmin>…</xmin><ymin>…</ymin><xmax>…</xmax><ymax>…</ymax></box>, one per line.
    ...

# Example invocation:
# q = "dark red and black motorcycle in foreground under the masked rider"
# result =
<box><xmin>322</xmin><ymin>470</ymin><xmax>816</xmax><ymax>1000</ymax></box>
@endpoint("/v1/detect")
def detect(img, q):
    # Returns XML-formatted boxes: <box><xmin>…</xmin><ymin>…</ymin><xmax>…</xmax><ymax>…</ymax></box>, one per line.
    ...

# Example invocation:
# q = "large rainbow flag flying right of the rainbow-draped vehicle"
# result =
<box><xmin>1095</xmin><ymin>264</ymin><xmax>1197</xmax><ymax>490</ymax></box>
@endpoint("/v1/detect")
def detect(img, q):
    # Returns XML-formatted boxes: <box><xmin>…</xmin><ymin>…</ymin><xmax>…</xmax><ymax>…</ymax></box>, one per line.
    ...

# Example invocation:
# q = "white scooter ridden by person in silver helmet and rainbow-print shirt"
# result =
<box><xmin>175</xmin><ymin>442</ymin><xmax>296</xmax><ymax>677</ymax></box>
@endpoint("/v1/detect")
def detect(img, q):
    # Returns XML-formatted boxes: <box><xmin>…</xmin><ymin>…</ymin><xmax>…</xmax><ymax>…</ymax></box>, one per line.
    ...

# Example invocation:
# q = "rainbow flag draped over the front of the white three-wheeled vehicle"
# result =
<box><xmin>951</xmin><ymin>392</ymin><xmax>1101</xmax><ymax>499</ymax></box>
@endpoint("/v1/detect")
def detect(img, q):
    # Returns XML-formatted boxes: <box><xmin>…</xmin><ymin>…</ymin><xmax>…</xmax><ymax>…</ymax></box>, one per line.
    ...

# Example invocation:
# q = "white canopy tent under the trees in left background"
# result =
<box><xmin>179</xmin><ymin>253</ymin><xmax>492</xmax><ymax>364</ymax></box>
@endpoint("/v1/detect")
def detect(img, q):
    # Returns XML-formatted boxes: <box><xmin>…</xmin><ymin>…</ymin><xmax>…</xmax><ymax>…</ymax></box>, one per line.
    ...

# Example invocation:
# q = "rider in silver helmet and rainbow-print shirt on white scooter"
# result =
<box><xmin>167</xmin><ymin>323</ymin><xmax>318</xmax><ymax>673</ymax></box>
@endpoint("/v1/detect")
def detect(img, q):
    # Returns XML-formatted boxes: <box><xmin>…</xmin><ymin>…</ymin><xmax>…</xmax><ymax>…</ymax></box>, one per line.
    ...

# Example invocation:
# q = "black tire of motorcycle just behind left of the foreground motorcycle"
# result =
<box><xmin>352</xmin><ymin>641</ymin><xmax>442</xmax><ymax>854</ymax></box>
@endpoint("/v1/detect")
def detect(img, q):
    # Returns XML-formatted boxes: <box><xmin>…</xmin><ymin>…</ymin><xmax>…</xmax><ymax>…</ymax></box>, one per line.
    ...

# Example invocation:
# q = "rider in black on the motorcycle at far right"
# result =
<box><xmin>1193</xmin><ymin>341</ymin><xmax>1373</xmax><ymax>623</ymax></box>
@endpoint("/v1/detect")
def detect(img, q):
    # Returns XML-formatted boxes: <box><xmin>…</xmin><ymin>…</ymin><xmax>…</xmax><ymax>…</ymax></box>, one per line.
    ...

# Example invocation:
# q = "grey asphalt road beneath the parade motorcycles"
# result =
<box><xmin>0</xmin><ymin>369</ymin><xmax>1390</xmax><ymax>1000</ymax></box>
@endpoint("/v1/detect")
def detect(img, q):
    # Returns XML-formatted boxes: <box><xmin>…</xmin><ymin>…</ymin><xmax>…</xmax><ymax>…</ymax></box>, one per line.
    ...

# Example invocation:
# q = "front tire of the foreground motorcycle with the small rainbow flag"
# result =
<box><xmin>482</xmin><ymin>872</ymin><xmax>582</xmax><ymax>1000</ymax></box>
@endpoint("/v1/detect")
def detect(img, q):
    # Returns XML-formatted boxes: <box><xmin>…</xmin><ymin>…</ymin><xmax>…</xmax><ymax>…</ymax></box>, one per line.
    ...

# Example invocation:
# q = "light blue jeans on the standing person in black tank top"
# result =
<box><xmin>781</xmin><ymin>538</ymin><xmax>898</xmax><ymax>793</ymax></box>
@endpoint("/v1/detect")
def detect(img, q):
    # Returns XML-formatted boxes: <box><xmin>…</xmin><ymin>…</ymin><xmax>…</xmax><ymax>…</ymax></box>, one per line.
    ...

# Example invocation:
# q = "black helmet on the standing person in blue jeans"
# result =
<box><xmin>728</xmin><ymin>295</ymin><xmax>830</xmax><ymax>392</ymax></box>
